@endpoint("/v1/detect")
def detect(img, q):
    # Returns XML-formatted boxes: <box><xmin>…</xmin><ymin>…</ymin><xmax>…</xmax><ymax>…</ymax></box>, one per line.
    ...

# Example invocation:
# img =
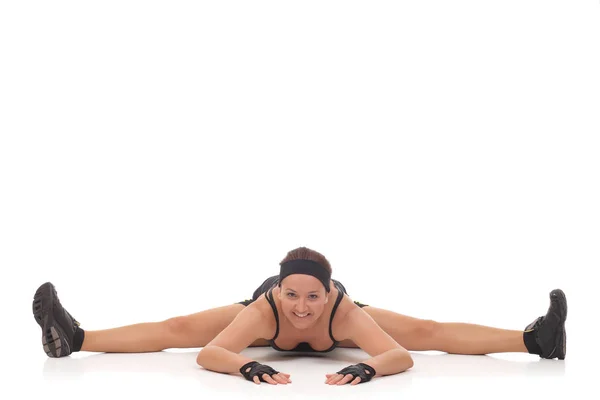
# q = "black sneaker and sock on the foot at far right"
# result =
<box><xmin>523</xmin><ymin>289</ymin><xmax>567</xmax><ymax>360</ymax></box>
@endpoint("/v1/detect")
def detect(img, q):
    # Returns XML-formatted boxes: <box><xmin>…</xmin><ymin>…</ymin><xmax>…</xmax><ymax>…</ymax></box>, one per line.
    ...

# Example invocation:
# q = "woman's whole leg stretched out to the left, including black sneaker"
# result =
<box><xmin>33</xmin><ymin>282</ymin><xmax>267</xmax><ymax>357</ymax></box>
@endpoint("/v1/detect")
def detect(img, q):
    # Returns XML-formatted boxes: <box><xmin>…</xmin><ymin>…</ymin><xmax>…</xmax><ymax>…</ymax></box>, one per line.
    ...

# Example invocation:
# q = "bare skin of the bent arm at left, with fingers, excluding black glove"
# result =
<box><xmin>196</xmin><ymin>306</ymin><xmax>289</xmax><ymax>383</ymax></box>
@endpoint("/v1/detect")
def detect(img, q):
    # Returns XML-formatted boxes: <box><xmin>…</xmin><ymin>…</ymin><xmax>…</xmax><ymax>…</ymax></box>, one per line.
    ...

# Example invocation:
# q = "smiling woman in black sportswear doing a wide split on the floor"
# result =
<box><xmin>33</xmin><ymin>247</ymin><xmax>567</xmax><ymax>385</ymax></box>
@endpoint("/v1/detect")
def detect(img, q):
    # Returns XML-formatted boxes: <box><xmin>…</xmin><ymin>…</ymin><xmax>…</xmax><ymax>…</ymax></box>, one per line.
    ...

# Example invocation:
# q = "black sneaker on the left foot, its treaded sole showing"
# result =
<box><xmin>33</xmin><ymin>282</ymin><xmax>79</xmax><ymax>357</ymax></box>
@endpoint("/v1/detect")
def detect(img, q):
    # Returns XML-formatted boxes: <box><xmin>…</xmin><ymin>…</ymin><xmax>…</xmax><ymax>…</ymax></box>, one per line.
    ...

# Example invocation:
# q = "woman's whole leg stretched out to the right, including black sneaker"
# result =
<box><xmin>341</xmin><ymin>289</ymin><xmax>567</xmax><ymax>359</ymax></box>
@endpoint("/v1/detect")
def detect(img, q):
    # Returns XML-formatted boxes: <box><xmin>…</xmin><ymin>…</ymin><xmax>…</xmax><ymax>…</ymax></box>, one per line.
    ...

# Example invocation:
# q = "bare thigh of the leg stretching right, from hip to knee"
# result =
<box><xmin>339</xmin><ymin>306</ymin><xmax>435</xmax><ymax>350</ymax></box>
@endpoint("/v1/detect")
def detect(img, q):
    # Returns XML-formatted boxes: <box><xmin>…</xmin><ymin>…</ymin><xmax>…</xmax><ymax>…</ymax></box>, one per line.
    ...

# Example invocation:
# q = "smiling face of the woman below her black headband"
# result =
<box><xmin>279</xmin><ymin>274</ymin><xmax>328</xmax><ymax>329</ymax></box>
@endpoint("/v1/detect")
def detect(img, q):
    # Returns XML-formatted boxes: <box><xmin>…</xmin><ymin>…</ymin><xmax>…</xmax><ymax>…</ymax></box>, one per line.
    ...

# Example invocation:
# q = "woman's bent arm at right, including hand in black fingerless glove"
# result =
<box><xmin>325</xmin><ymin>308</ymin><xmax>414</xmax><ymax>385</ymax></box>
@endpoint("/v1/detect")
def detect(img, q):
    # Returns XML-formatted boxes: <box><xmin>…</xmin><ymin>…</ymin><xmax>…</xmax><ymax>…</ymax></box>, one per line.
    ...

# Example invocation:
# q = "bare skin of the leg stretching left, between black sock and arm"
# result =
<box><xmin>81</xmin><ymin>304</ymin><xmax>267</xmax><ymax>353</ymax></box>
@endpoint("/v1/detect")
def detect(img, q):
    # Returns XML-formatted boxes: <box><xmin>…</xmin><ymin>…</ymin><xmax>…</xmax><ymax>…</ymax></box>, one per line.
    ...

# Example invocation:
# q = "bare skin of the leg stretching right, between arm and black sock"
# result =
<box><xmin>341</xmin><ymin>306</ymin><xmax>527</xmax><ymax>354</ymax></box>
